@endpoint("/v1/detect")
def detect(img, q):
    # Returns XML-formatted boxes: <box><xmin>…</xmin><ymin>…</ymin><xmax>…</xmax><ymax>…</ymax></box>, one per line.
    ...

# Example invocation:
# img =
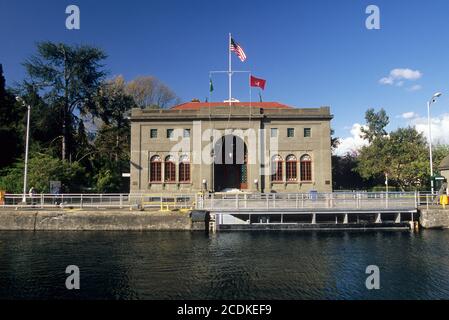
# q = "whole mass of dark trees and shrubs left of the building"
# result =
<box><xmin>0</xmin><ymin>42</ymin><xmax>176</xmax><ymax>193</ymax></box>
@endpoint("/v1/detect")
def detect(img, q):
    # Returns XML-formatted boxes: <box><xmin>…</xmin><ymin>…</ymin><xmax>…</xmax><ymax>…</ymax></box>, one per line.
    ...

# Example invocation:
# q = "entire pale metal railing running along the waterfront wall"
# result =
<box><xmin>0</xmin><ymin>192</ymin><xmax>439</xmax><ymax>210</ymax></box>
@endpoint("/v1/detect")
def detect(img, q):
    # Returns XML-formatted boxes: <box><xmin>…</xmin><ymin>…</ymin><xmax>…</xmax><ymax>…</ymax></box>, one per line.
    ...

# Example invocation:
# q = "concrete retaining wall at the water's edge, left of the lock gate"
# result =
<box><xmin>0</xmin><ymin>210</ymin><xmax>192</xmax><ymax>231</ymax></box>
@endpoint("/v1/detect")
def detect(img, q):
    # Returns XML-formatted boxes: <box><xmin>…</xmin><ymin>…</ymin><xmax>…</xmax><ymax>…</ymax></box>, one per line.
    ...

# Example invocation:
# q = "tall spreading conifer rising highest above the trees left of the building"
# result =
<box><xmin>24</xmin><ymin>42</ymin><xmax>106</xmax><ymax>160</ymax></box>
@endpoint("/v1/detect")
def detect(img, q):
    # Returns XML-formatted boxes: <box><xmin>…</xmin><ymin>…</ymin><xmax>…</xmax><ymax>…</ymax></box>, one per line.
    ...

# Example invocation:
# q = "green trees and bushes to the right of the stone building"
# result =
<box><xmin>332</xmin><ymin>109</ymin><xmax>449</xmax><ymax>191</ymax></box>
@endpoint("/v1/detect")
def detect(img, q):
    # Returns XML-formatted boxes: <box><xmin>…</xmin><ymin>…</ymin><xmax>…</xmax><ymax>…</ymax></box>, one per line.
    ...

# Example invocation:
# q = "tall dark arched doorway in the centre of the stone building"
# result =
<box><xmin>214</xmin><ymin>135</ymin><xmax>248</xmax><ymax>191</ymax></box>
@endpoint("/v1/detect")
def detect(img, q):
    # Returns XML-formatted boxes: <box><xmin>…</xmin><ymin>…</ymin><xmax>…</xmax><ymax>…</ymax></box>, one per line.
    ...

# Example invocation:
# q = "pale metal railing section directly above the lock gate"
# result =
<box><xmin>197</xmin><ymin>192</ymin><xmax>418</xmax><ymax>211</ymax></box>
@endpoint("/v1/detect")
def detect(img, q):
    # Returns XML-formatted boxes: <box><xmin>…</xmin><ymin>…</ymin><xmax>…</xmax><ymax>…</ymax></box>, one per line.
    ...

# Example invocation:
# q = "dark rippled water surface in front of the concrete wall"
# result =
<box><xmin>0</xmin><ymin>231</ymin><xmax>449</xmax><ymax>299</ymax></box>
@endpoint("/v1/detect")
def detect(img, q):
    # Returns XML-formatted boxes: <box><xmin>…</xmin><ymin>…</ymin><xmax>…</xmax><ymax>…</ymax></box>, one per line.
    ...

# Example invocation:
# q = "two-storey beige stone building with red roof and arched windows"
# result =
<box><xmin>130</xmin><ymin>101</ymin><xmax>333</xmax><ymax>194</ymax></box>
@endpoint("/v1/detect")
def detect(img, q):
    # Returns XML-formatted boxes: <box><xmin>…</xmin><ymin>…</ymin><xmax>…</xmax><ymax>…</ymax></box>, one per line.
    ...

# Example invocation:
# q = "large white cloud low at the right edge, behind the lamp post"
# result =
<box><xmin>409</xmin><ymin>113</ymin><xmax>449</xmax><ymax>144</ymax></box>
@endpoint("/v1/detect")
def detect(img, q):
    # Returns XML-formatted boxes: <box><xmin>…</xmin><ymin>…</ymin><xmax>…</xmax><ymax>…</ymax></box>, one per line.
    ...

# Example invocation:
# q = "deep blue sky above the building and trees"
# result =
<box><xmin>0</xmin><ymin>0</ymin><xmax>449</xmax><ymax>153</ymax></box>
